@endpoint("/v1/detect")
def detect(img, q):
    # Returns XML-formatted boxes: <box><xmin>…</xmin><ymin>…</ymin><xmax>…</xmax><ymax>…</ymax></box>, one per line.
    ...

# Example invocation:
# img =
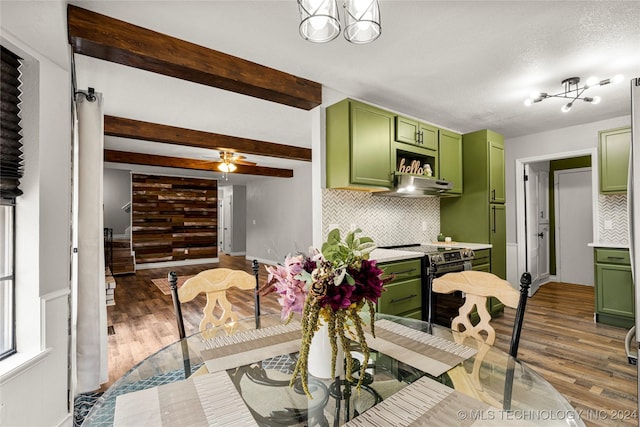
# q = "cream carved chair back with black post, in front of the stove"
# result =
<box><xmin>432</xmin><ymin>270</ymin><xmax>531</xmax><ymax>357</ymax></box>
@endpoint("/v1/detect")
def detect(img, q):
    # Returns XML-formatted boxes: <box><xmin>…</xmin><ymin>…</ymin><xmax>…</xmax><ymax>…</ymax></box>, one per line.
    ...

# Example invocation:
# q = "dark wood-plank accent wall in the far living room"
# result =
<box><xmin>131</xmin><ymin>174</ymin><xmax>218</xmax><ymax>264</ymax></box>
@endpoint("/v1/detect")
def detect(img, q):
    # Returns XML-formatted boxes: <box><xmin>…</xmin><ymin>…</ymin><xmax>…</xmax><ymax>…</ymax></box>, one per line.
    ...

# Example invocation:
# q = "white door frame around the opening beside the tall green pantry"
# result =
<box><xmin>515</xmin><ymin>147</ymin><xmax>600</xmax><ymax>296</ymax></box>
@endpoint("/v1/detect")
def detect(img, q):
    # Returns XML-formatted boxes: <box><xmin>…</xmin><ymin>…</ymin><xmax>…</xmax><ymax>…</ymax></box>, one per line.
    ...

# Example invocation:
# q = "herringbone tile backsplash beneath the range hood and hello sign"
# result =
<box><xmin>322</xmin><ymin>189</ymin><xmax>440</xmax><ymax>246</ymax></box>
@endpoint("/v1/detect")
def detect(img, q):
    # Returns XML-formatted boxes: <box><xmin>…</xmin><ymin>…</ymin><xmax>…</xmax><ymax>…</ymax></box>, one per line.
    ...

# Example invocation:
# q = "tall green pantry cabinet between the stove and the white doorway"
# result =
<box><xmin>440</xmin><ymin>130</ymin><xmax>507</xmax><ymax>279</ymax></box>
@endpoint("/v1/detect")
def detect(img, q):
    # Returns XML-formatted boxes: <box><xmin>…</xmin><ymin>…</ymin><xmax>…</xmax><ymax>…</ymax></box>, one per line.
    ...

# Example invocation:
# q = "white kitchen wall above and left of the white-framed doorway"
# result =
<box><xmin>505</xmin><ymin>113</ymin><xmax>631</xmax><ymax>247</ymax></box>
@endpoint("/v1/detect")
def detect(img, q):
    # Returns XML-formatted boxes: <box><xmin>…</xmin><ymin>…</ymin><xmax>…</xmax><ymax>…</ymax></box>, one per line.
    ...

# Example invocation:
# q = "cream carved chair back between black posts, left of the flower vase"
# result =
<box><xmin>169</xmin><ymin>260</ymin><xmax>260</xmax><ymax>338</ymax></box>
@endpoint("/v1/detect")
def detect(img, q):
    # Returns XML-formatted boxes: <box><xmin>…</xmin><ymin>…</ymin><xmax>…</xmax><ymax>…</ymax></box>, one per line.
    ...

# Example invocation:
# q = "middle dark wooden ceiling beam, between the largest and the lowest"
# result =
<box><xmin>104</xmin><ymin>116</ymin><xmax>311</xmax><ymax>162</ymax></box>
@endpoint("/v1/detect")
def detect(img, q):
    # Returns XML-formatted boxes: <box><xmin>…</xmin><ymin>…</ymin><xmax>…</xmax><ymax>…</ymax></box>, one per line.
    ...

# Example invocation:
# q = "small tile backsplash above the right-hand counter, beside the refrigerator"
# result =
<box><xmin>598</xmin><ymin>194</ymin><xmax>629</xmax><ymax>245</ymax></box>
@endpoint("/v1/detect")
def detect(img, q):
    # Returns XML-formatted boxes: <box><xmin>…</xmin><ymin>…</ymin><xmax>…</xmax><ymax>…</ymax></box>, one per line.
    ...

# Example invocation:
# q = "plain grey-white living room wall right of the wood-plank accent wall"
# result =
<box><xmin>247</xmin><ymin>162</ymin><xmax>312</xmax><ymax>264</ymax></box>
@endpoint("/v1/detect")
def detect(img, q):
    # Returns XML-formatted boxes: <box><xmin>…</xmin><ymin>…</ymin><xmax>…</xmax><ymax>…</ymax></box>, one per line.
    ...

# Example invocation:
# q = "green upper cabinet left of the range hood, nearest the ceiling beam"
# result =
<box><xmin>326</xmin><ymin>99</ymin><xmax>394</xmax><ymax>190</ymax></box>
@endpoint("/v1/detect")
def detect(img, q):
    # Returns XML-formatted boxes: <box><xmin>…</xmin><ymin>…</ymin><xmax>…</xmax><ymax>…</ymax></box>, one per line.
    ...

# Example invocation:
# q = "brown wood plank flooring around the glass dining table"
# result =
<box><xmin>102</xmin><ymin>260</ymin><xmax>638</xmax><ymax>426</ymax></box>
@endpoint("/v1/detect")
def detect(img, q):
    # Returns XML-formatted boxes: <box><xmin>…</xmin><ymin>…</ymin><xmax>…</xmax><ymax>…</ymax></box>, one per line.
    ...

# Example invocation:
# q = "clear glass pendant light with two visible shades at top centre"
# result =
<box><xmin>298</xmin><ymin>0</ymin><xmax>382</xmax><ymax>44</ymax></box>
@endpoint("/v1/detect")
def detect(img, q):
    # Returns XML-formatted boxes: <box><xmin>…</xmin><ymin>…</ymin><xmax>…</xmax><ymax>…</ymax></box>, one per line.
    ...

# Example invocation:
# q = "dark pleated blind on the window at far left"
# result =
<box><xmin>0</xmin><ymin>46</ymin><xmax>23</xmax><ymax>199</ymax></box>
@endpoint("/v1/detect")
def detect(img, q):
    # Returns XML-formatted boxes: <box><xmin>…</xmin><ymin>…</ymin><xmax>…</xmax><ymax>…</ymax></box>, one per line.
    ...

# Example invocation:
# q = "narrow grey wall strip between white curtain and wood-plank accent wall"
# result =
<box><xmin>103</xmin><ymin>169</ymin><xmax>131</xmax><ymax>235</ymax></box>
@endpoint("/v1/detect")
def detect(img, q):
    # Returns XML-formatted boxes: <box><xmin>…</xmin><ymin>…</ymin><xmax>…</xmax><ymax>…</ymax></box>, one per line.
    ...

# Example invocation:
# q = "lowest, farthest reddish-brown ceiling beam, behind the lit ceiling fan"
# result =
<box><xmin>104</xmin><ymin>150</ymin><xmax>293</xmax><ymax>178</ymax></box>
